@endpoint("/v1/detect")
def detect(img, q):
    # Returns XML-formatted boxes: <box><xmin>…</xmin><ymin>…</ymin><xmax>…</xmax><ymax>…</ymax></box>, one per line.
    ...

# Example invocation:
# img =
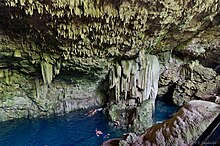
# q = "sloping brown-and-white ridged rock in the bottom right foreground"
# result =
<box><xmin>103</xmin><ymin>100</ymin><xmax>220</xmax><ymax>146</ymax></box>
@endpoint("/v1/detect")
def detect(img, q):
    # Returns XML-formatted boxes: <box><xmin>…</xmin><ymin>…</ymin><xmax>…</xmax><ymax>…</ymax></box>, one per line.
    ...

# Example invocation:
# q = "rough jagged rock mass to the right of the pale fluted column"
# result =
<box><xmin>159</xmin><ymin>59</ymin><xmax>220</xmax><ymax>106</ymax></box>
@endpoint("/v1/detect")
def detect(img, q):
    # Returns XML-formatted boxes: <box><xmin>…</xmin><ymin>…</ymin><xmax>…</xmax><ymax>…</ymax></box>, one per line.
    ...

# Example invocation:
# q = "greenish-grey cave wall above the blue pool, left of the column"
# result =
<box><xmin>0</xmin><ymin>70</ymin><xmax>104</xmax><ymax>121</ymax></box>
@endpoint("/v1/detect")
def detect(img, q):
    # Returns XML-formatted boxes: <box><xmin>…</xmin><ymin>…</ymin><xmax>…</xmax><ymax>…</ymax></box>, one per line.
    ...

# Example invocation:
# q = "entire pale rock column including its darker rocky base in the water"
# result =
<box><xmin>108</xmin><ymin>50</ymin><xmax>160</xmax><ymax>132</ymax></box>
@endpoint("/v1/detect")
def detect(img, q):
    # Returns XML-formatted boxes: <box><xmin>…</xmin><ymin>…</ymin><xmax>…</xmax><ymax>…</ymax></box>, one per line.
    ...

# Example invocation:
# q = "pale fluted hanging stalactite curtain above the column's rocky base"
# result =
<box><xmin>109</xmin><ymin>50</ymin><xmax>160</xmax><ymax>105</ymax></box>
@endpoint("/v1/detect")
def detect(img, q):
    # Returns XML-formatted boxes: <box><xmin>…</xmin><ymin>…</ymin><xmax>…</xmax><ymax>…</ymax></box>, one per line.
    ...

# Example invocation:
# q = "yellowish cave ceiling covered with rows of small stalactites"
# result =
<box><xmin>0</xmin><ymin>0</ymin><xmax>220</xmax><ymax>75</ymax></box>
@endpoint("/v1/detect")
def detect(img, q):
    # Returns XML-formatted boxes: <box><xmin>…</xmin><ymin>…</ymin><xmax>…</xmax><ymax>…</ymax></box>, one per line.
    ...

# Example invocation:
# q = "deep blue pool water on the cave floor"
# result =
<box><xmin>0</xmin><ymin>102</ymin><xmax>180</xmax><ymax>146</ymax></box>
